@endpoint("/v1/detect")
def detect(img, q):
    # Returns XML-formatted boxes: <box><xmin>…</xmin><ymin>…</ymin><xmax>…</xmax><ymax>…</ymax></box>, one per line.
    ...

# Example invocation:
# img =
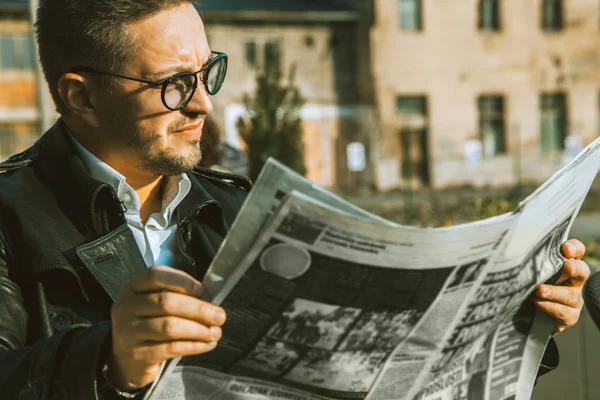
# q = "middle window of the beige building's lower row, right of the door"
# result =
<box><xmin>477</xmin><ymin>96</ymin><xmax>506</xmax><ymax>157</ymax></box>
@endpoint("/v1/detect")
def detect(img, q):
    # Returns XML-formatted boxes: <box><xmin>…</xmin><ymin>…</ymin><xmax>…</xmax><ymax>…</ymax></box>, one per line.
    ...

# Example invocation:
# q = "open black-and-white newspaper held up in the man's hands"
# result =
<box><xmin>147</xmin><ymin>140</ymin><xmax>600</xmax><ymax>400</ymax></box>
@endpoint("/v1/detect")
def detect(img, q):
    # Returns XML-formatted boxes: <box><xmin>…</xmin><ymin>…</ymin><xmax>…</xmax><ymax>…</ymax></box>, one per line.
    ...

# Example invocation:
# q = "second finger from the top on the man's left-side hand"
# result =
<box><xmin>131</xmin><ymin>292</ymin><xmax>226</xmax><ymax>326</ymax></box>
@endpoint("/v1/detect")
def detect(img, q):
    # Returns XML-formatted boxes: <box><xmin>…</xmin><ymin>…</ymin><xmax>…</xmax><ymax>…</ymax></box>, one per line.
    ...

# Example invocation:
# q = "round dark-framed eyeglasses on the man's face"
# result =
<box><xmin>70</xmin><ymin>51</ymin><xmax>227</xmax><ymax>111</ymax></box>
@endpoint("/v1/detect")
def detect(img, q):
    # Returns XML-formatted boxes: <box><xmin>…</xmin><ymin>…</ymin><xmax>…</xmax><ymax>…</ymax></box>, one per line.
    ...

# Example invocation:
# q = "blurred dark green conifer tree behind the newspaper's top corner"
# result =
<box><xmin>237</xmin><ymin>45</ymin><xmax>306</xmax><ymax>180</ymax></box>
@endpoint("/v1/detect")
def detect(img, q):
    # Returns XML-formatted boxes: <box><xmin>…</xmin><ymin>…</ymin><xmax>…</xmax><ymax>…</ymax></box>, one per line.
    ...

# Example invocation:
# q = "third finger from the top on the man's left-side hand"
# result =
<box><xmin>129</xmin><ymin>317</ymin><xmax>223</xmax><ymax>343</ymax></box>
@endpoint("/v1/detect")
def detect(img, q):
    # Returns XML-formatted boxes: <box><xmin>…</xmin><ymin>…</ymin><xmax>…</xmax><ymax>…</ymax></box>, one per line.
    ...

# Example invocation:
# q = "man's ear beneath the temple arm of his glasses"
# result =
<box><xmin>58</xmin><ymin>72</ymin><xmax>99</xmax><ymax>127</ymax></box>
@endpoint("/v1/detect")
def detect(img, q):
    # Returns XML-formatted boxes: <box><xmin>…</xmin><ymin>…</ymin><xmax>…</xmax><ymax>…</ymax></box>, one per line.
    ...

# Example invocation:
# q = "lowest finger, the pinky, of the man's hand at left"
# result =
<box><xmin>133</xmin><ymin>340</ymin><xmax>217</xmax><ymax>364</ymax></box>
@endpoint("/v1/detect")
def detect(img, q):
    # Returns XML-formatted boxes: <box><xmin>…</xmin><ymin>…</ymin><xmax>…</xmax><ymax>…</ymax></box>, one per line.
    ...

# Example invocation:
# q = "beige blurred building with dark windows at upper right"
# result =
<box><xmin>371</xmin><ymin>0</ymin><xmax>600</xmax><ymax>189</ymax></box>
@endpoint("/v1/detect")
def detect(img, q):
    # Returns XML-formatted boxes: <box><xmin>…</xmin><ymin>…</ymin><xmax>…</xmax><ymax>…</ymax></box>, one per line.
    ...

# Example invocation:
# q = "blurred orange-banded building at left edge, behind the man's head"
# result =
<box><xmin>0</xmin><ymin>0</ymin><xmax>39</xmax><ymax>160</ymax></box>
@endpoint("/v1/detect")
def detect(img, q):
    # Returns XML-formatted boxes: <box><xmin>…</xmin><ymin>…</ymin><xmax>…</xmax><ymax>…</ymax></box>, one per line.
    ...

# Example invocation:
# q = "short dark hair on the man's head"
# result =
<box><xmin>35</xmin><ymin>0</ymin><xmax>195</xmax><ymax>114</ymax></box>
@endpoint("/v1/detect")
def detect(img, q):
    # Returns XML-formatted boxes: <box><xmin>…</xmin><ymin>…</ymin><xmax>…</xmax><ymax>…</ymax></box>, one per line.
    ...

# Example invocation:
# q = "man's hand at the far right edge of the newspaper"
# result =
<box><xmin>533</xmin><ymin>239</ymin><xmax>590</xmax><ymax>335</ymax></box>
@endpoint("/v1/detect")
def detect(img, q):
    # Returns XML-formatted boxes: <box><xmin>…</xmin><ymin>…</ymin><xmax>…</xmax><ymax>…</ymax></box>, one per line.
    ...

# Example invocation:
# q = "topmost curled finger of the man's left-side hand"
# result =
<box><xmin>129</xmin><ymin>265</ymin><xmax>204</xmax><ymax>297</ymax></box>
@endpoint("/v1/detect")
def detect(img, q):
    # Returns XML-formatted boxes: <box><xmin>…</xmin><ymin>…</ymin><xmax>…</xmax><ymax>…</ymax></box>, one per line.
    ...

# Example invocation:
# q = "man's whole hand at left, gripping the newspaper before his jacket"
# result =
<box><xmin>108</xmin><ymin>266</ymin><xmax>226</xmax><ymax>391</ymax></box>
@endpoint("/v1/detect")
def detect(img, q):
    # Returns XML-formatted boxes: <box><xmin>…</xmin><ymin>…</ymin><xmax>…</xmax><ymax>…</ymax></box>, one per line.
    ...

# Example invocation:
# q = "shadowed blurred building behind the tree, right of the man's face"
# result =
<box><xmin>199</xmin><ymin>0</ymin><xmax>375</xmax><ymax>187</ymax></box>
